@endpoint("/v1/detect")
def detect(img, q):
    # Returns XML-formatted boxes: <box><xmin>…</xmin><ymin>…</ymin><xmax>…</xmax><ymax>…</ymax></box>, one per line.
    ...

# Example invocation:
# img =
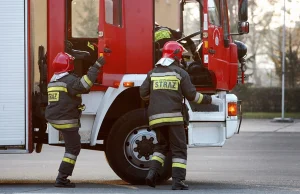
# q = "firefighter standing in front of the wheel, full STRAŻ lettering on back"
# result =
<box><xmin>140</xmin><ymin>41</ymin><xmax>222</xmax><ymax>190</ymax></box>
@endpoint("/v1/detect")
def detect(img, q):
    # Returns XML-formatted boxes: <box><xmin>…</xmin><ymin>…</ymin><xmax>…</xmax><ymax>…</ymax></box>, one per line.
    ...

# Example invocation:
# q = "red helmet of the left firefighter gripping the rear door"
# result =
<box><xmin>52</xmin><ymin>52</ymin><xmax>74</xmax><ymax>74</ymax></box>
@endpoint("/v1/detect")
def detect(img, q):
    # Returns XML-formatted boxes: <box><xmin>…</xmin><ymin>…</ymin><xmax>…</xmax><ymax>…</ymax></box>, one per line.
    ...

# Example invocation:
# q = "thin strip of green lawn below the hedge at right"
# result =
<box><xmin>243</xmin><ymin>112</ymin><xmax>300</xmax><ymax>119</ymax></box>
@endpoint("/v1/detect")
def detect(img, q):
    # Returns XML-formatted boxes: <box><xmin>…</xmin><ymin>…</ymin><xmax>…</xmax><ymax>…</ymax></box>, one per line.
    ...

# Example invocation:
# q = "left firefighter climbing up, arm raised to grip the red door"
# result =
<box><xmin>45</xmin><ymin>52</ymin><xmax>105</xmax><ymax>187</ymax></box>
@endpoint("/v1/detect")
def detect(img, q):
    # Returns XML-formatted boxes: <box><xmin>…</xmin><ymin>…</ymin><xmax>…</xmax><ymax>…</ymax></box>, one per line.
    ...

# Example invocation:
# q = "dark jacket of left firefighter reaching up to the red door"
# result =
<box><xmin>45</xmin><ymin>64</ymin><xmax>99</xmax><ymax>129</ymax></box>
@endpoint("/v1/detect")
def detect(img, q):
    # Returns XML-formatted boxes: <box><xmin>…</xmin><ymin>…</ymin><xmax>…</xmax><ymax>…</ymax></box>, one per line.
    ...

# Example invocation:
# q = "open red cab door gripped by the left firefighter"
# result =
<box><xmin>98</xmin><ymin>0</ymin><xmax>126</xmax><ymax>86</ymax></box>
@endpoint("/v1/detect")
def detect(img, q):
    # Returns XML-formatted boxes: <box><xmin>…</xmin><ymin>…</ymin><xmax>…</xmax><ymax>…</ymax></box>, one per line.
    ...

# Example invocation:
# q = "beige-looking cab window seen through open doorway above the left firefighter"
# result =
<box><xmin>71</xmin><ymin>0</ymin><xmax>99</xmax><ymax>38</ymax></box>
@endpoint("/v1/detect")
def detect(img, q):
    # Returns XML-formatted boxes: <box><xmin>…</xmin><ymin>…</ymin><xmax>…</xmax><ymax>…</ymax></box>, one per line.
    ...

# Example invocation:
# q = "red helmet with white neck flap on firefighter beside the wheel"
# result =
<box><xmin>156</xmin><ymin>41</ymin><xmax>187</xmax><ymax>66</ymax></box>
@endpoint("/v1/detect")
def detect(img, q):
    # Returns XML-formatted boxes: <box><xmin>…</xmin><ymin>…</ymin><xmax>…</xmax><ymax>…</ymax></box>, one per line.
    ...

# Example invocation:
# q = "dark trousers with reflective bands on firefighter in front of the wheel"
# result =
<box><xmin>150</xmin><ymin>125</ymin><xmax>187</xmax><ymax>180</ymax></box>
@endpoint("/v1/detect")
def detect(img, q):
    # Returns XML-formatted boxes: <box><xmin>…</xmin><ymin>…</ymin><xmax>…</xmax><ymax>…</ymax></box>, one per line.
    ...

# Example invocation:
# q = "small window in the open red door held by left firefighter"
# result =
<box><xmin>105</xmin><ymin>0</ymin><xmax>122</xmax><ymax>27</ymax></box>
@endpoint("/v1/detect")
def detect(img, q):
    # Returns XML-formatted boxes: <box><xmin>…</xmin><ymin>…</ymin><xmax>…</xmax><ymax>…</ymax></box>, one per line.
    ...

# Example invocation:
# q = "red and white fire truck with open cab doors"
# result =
<box><xmin>0</xmin><ymin>0</ymin><xmax>249</xmax><ymax>184</ymax></box>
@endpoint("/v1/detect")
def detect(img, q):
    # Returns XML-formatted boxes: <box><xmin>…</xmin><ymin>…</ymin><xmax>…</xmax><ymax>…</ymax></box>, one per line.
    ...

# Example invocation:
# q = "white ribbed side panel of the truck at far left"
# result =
<box><xmin>0</xmin><ymin>0</ymin><xmax>28</xmax><ymax>149</ymax></box>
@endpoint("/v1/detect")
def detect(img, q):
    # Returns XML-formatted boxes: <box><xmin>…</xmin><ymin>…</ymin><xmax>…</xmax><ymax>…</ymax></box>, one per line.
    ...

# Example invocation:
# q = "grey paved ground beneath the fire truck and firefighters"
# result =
<box><xmin>0</xmin><ymin>120</ymin><xmax>300</xmax><ymax>194</ymax></box>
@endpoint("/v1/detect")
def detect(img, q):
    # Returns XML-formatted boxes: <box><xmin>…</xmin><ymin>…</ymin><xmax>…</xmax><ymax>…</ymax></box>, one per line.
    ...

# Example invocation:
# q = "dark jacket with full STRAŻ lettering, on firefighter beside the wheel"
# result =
<box><xmin>140</xmin><ymin>61</ymin><xmax>211</xmax><ymax>128</ymax></box>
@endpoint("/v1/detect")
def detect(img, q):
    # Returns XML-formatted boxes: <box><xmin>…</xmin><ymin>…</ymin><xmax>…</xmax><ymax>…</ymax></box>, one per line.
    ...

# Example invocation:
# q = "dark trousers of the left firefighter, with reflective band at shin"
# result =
<box><xmin>58</xmin><ymin>128</ymin><xmax>81</xmax><ymax>176</ymax></box>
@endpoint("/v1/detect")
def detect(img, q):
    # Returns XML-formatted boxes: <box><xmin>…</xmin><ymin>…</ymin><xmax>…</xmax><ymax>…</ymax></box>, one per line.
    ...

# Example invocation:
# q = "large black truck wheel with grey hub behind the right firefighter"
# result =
<box><xmin>105</xmin><ymin>109</ymin><xmax>172</xmax><ymax>185</ymax></box>
